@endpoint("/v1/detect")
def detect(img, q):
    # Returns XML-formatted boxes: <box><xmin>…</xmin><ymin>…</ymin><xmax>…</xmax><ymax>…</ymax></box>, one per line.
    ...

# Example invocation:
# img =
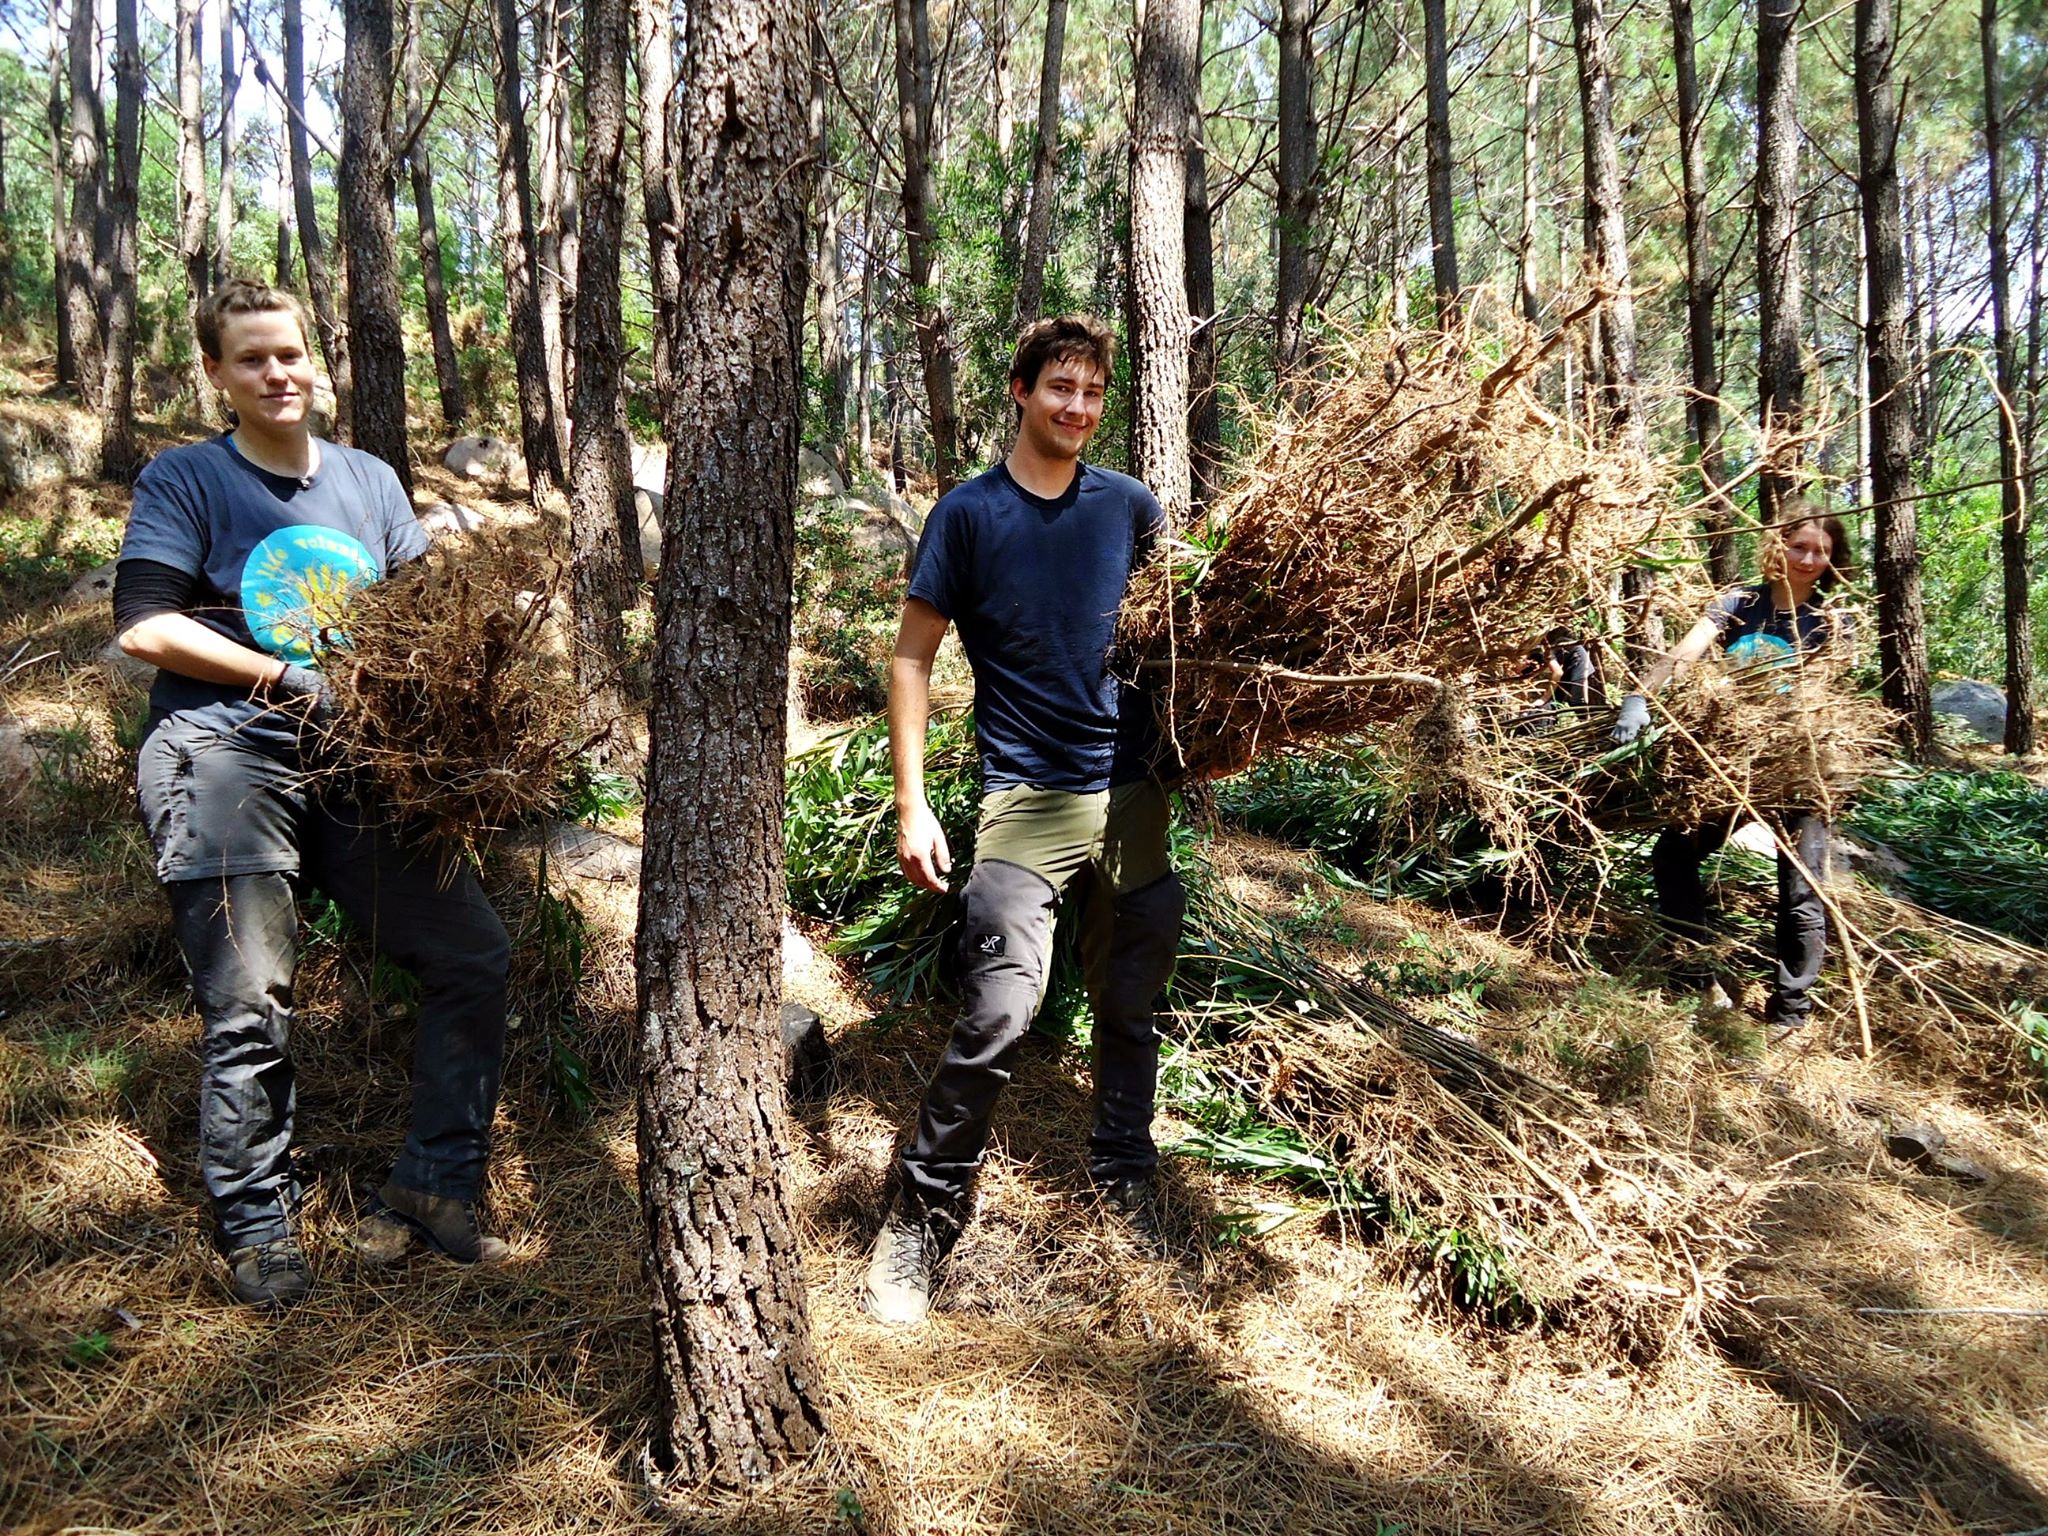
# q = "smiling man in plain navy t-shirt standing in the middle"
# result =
<box><xmin>862</xmin><ymin>315</ymin><xmax>1184</xmax><ymax>1323</ymax></box>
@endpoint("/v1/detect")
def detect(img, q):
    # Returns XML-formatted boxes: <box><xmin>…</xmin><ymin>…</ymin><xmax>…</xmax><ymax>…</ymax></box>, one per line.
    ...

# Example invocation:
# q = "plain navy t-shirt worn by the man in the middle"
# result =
<box><xmin>909</xmin><ymin>463</ymin><xmax>1165</xmax><ymax>795</ymax></box>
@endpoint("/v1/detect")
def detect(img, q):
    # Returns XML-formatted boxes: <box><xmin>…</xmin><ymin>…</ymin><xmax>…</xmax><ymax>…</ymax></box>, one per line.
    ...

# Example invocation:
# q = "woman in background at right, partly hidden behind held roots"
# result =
<box><xmin>1612</xmin><ymin>514</ymin><xmax>1853</xmax><ymax>1042</ymax></box>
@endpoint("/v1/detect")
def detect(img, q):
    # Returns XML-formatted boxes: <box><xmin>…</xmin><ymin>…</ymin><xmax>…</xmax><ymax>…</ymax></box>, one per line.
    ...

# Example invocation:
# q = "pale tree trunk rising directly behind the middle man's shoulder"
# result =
<box><xmin>1130</xmin><ymin>0</ymin><xmax>1202</xmax><ymax>528</ymax></box>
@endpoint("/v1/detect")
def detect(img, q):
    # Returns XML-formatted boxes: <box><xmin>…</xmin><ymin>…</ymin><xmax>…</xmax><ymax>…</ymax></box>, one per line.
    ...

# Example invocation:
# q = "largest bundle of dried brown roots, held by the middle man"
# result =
<box><xmin>1122</xmin><ymin>311</ymin><xmax>1665</xmax><ymax>778</ymax></box>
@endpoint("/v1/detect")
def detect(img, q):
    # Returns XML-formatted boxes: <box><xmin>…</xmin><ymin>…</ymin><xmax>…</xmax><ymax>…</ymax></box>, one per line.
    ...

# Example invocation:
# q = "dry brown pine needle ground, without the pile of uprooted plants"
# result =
<box><xmin>0</xmin><ymin>403</ymin><xmax>2048</xmax><ymax>1536</ymax></box>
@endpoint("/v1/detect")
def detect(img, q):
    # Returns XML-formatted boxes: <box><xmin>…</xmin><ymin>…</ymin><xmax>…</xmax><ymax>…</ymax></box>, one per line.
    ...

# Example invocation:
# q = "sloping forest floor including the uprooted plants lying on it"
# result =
<box><xmin>0</xmin><ymin>393</ymin><xmax>2048</xmax><ymax>1536</ymax></box>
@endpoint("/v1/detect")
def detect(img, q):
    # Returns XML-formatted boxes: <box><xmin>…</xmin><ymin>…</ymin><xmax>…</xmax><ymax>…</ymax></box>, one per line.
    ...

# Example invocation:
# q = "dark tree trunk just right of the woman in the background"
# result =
<box><xmin>1855</xmin><ymin>0</ymin><xmax>1933</xmax><ymax>750</ymax></box>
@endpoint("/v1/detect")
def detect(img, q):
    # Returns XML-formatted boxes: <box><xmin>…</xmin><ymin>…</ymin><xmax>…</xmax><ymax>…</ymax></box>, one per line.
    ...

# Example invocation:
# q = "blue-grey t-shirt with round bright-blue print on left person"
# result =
<box><xmin>121</xmin><ymin>434</ymin><xmax>428</xmax><ymax>745</ymax></box>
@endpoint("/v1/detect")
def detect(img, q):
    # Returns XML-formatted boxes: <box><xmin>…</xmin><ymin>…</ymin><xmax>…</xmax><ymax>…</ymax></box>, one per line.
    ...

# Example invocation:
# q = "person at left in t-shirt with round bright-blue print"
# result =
<box><xmin>115</xmin><ymin>279</ymin><xmax>510</xmax><ymax>1307</ymax></box>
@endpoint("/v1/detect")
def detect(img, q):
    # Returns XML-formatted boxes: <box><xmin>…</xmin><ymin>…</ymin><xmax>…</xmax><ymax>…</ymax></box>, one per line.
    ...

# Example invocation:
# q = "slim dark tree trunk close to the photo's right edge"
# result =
<box><xmin>1982</xmin><ymin>0</ymin><xmax>2040</xmax><ymax>758</ymax></box>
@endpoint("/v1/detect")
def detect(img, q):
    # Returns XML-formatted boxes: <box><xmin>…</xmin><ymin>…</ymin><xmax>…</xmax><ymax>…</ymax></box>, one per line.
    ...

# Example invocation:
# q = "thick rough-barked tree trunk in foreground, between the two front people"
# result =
<box><xmin>638</xmin><ymin>0</ymin><xmax>825</xmax><ymax>1485</ymax></box>
